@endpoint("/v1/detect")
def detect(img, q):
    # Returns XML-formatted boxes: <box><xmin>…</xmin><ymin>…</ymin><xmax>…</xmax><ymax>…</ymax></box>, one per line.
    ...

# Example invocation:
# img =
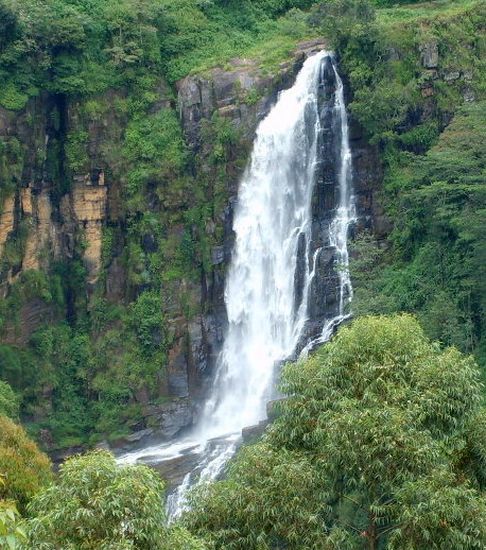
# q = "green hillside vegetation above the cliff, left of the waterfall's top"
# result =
<box><xmin>0</xmin><ymin>0</ymin><xmax>313</xmax><ymax>110</ymax></box>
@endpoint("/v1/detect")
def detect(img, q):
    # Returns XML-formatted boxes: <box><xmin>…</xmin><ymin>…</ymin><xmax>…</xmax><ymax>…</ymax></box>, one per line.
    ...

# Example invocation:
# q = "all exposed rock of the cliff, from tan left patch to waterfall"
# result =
<box><xmin>0</xmin><ymin>41</ymin><xmax>387</xmax><ymax>452</ymax></box>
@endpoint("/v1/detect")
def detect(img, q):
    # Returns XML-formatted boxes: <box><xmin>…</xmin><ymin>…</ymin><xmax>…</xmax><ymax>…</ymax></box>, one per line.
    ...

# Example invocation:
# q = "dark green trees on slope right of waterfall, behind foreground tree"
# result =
<box><xmin>353</xmin><ymin>102</ymin><xmax>486</xmax><ymax>361</ymax></box>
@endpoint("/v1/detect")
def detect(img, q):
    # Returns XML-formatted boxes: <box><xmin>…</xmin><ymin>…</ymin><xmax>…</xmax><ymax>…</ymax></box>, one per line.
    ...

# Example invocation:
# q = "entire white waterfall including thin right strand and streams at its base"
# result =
<box><xmin>119</xmin><ymin>51</ymin><xmax>354</xmax><ymax>517</ymax></box>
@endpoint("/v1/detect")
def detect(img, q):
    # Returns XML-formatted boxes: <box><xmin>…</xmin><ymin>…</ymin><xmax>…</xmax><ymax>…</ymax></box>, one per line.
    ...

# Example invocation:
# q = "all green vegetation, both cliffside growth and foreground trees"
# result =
<box><xmin>0</xmin><ymin>0</ymin><xmax>486</xmax><ymax>550</ymax></box>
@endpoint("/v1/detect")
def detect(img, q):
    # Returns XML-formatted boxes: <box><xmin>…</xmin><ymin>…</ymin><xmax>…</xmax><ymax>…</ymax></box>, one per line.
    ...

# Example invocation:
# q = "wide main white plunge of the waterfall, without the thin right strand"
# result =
<box><xmin>195</xmin><ymin>52</ymin><xmax>326</xmax><ymax>437</ymax></box>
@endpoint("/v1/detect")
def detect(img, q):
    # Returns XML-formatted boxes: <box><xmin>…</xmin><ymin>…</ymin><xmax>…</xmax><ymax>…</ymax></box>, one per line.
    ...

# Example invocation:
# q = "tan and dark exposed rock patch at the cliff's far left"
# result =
<box><xmin>0</xmin><ymin>97</ymin><xmax>107</xmax><ymax>290</ymax></box>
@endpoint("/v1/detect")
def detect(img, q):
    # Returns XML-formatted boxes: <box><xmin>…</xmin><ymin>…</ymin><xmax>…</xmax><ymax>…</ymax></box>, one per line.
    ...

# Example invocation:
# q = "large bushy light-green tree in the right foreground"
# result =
<box><xmin>183</xmin><ymin>315</ymin><xmax>486</xmax><ymax>550</ymax></box>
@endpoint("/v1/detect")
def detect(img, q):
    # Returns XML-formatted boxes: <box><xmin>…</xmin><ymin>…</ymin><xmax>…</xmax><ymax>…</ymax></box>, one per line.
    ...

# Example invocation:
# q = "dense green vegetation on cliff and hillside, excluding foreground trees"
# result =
<box><xmin>0</xmin><ymin>0</ymin><xmax>485</xmax><ymax>448</ymax></box>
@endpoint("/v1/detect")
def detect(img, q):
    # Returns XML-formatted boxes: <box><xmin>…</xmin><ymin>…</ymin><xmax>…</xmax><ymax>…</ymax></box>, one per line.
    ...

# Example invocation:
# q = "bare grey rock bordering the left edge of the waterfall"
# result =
<box><xmin>177</xmin><ymin>40</ymin><xmax>346</xmax><ymax>398</ymax></box>
